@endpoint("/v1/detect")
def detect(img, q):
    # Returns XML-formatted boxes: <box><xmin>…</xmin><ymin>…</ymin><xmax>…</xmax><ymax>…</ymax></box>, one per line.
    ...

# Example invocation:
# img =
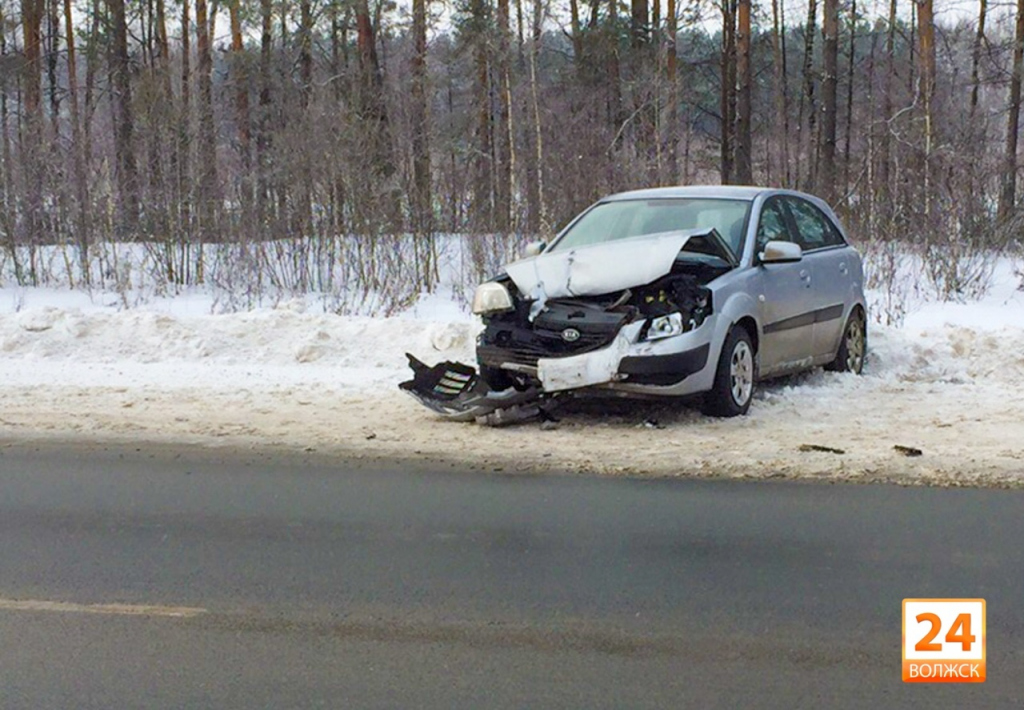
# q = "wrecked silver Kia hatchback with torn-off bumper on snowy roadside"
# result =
<box><xmin>401</xmin><ymin>186</ymin><xmax>867</xmax><ymax>423</ymax></box>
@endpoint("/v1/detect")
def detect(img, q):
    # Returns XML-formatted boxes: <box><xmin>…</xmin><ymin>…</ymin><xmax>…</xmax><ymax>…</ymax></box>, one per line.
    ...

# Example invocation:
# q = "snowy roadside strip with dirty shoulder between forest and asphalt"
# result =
<box><xmin>0</xmin><ymin>262</ymin><xmax>1024</xmax><ymax>484</ymax></box>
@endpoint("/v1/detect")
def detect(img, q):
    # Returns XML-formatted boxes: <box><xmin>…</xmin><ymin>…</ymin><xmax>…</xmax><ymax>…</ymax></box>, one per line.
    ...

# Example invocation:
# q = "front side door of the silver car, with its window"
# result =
<box><xmin>755</xmin><ymin>197</ymin><xmax>814</xmax><ymax>376</ymax></box>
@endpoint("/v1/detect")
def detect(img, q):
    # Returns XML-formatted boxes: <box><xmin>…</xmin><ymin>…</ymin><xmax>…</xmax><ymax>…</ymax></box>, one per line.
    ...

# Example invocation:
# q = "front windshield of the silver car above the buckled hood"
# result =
<box><xmin>550</xmin><ymin>198</ymin><xmax>751</xmax><ymax>257</ymax></box>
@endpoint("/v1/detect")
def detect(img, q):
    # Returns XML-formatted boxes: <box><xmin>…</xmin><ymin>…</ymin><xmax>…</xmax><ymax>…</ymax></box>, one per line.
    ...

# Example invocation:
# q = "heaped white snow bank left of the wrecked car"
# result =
<box><xmin>0</xmin><ymin>284</ymin><xmax>475</xmax><ymax>392</ymax></box>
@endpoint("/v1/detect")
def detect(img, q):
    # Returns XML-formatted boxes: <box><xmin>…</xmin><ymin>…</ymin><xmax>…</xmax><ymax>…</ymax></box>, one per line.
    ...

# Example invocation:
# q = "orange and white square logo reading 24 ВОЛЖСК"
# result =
<box><xmin>903</xmin><ymin>599</ymin><xmax>985</xmax><ymax>683</ymax></box>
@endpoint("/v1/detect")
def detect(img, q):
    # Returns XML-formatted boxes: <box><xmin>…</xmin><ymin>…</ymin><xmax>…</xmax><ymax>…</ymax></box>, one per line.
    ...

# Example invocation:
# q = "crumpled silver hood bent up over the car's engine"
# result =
<box><xmin>505</xmin><ymin>229</ymin><xmax>731</xmax><ymax>301</ymax></box>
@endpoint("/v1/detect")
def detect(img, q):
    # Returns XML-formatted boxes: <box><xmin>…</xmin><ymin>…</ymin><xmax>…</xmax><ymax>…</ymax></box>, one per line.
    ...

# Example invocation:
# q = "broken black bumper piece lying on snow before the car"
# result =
<box><xmin>398</xmin><ymin>352</ymin><xmax>543</xmax><ymax>426</ymax></box>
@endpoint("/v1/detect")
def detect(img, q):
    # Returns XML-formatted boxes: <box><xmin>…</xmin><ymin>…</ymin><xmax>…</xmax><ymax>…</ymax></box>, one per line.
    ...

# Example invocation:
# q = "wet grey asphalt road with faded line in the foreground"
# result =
<box><xmin>0</xmin><ymin>446</ymin><xmax>1024</xmax><ymax>710</ymax></box>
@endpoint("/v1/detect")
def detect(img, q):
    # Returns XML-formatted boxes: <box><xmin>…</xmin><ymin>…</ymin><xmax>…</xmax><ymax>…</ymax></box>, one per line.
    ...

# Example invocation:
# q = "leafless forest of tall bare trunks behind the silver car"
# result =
<box><xmin>0</xmin><ymin>0</ymin><xmax>1024</xmax><ymax>288</ymax></box>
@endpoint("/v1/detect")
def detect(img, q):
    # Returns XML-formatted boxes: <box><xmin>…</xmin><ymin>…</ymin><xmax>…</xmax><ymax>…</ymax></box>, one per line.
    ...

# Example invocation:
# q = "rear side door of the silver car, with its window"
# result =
<box><xmin>785</xmin><ymin>196</ymin><xmax>856</xmax><ymax>360</ymax></box>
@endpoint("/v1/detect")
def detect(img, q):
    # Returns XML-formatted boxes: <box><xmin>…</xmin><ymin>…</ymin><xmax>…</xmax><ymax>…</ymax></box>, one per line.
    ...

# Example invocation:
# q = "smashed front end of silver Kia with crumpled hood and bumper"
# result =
<box><xmin>476</xmin><ymin>229</ymin><xmax>731</xmax><ymax>393</ymax></box>
